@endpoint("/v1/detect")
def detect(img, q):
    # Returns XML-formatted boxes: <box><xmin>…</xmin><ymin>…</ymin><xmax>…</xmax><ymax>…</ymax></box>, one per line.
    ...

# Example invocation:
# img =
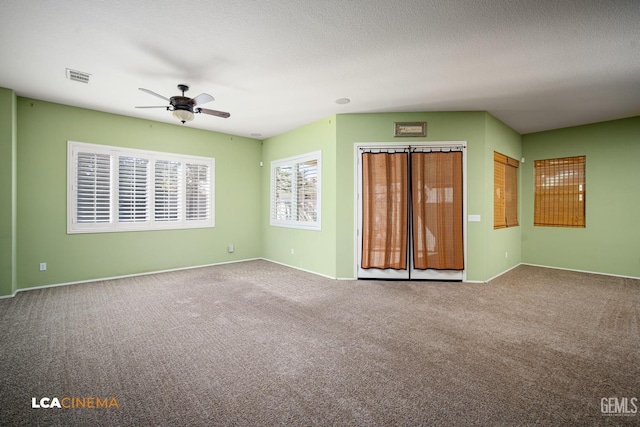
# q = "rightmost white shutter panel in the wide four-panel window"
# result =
<box><xmin>185</xmin><ymin>163</ymin><xmax>211</xmax><ymax>221</ymax></box>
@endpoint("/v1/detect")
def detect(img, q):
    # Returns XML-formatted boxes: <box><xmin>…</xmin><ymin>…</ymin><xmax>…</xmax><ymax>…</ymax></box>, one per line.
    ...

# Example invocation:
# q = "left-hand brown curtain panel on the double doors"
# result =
<box><xmin>362</xmin><ymin>153</ymin><xmax>409</xmax><ymax>270</ymax></box>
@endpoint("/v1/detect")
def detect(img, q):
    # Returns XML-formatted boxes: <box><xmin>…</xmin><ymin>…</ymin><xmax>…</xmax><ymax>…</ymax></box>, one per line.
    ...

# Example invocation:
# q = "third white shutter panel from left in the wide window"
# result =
<box><xmin>154</xmin><ymin>160</ymin><xmax>181</xmax><ymax>221</ymax></box>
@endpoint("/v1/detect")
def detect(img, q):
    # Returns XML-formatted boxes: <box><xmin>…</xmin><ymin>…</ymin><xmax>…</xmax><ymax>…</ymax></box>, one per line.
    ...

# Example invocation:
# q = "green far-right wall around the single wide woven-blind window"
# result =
<box><xmin>521</xmin><ymin>117</ymin><xmax>640</xmax><ymax>277</ymax></box>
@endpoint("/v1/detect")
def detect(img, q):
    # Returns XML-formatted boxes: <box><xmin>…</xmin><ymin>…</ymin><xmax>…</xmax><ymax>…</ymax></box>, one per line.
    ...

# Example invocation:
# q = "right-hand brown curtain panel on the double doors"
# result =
<box><xmin>411</xmin><ymin>151</ymin><xmax>464</xmax><ymax>270</ymax></box>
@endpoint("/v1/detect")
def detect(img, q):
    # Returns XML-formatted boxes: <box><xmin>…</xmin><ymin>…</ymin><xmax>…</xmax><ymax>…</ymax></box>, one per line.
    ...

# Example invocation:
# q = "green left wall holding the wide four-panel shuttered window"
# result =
<box><xmin>16</xmin><ymin>98</ymin><xmax>262</xmax><ymax>288</ymax></box>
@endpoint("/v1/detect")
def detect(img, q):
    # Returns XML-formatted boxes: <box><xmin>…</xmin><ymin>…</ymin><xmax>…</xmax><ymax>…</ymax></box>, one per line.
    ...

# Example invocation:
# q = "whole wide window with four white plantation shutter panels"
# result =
<box><xmin>67</xmin><ymin>141</ymin><xmax>215</xmax><ymax>233</ymax></box>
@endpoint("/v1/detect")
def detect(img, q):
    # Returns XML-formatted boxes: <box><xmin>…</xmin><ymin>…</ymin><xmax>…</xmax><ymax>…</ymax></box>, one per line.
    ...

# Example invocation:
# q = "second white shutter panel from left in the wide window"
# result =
<box><xmin>118</xmin><ymin>156</ymin><xmax>149</xmax><ymax>223</ymax></box>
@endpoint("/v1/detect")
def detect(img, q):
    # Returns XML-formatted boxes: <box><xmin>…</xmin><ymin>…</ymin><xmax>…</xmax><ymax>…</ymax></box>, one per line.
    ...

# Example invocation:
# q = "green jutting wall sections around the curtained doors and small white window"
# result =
<box><xmin>262</xmin><ymin>112</ymin><xmax>521</xmax><ymax>281</ymax></box>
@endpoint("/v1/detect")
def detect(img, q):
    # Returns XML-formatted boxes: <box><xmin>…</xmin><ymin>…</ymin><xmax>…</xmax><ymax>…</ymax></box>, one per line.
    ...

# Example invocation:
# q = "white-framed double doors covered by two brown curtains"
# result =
<box><xmin>356</xmin><ymin>142</ymin><xmax>466</xmax><ymax>281</ymax></box>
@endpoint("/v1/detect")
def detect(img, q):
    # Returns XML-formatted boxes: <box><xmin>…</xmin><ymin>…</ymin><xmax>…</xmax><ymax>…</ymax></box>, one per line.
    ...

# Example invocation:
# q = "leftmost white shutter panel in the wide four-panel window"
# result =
<box><xmin>74</xmin><ymin>152</ymin><xmax>111</xmax><ymax>224</ymax></box>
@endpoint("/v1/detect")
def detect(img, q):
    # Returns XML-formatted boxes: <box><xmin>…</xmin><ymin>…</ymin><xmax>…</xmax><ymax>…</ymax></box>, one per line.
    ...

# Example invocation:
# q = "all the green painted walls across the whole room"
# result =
<box><xmin>5</xmin><ymin>89</ymin><xmax>640</xmax><ymax>296</ymax></box>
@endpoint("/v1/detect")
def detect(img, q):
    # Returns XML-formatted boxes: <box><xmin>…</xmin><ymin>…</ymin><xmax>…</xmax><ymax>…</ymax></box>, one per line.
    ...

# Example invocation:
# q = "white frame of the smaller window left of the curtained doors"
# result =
<box><xmin>269</xmin><ymin>151</ymin><xmax>322</xmax><ymax>230</ymax></box>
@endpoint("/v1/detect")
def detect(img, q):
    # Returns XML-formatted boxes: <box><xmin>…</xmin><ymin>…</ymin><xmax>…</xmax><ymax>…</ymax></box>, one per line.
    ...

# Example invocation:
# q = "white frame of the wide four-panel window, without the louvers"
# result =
<box><xmin>67</xmin><ymin>141</ymin><xmax>215</xmax><ymax>234</ymax></box>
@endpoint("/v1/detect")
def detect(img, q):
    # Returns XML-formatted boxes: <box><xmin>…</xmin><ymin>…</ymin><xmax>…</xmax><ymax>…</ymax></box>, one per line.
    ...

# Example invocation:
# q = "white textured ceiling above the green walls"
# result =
<box><xmin>0</xmin><ymin>0</ymin><xmax>640</xmax><ymax>139</ymax></box>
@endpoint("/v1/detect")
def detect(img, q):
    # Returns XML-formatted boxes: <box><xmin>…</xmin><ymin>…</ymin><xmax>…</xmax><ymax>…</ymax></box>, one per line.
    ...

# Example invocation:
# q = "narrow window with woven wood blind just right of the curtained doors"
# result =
<box><xmin>493</xmin><ymin>151</ymin><xmax>520</xmax><ymax>229</ymax></box>
